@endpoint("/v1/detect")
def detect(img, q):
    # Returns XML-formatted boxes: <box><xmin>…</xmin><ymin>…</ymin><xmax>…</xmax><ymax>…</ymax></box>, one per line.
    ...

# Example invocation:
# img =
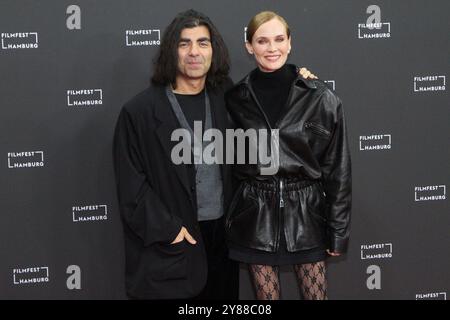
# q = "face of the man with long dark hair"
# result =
<box><xmin>178</xmin><ymin>26</ymin><xmax>213</xmax><ymax>79</ymax></box>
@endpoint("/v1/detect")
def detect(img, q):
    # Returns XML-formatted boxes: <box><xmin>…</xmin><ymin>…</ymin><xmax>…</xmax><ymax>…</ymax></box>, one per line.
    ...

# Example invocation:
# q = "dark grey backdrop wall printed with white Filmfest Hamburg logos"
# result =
<box><xmin>0</xmin><ymin>0</ymin><xmax>450</xmax><ymax>299</ymax></box>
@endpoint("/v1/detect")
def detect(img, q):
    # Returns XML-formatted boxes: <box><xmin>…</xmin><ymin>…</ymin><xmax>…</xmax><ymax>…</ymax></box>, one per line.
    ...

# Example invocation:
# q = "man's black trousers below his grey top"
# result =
<box><xmin>195</xmin><ymin>217</ymin><xmax>239</xmax><ymax>300</ymax></box>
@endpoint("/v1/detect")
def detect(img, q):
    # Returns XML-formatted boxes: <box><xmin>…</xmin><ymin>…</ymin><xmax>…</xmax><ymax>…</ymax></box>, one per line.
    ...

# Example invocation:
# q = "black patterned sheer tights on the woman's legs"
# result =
<box><xmin>249</xmin><ymin>261</ymin><xmax>327</xmax><ymax>300</ymax></box>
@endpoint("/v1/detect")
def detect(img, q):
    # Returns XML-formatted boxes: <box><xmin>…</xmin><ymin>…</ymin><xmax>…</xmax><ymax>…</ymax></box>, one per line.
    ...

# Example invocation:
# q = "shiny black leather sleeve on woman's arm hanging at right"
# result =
<box><xmin>321</xmin><ymin>99</ymin><xmax>352</xmax><ymax>253</ymax></box>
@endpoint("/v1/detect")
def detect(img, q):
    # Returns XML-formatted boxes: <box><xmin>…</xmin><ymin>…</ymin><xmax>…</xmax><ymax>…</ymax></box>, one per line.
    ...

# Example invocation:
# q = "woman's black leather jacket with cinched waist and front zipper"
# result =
<box><xmin>225</xmin><ymin>66</ymin><xmax>351</xmax><ymax>253</ymax></box>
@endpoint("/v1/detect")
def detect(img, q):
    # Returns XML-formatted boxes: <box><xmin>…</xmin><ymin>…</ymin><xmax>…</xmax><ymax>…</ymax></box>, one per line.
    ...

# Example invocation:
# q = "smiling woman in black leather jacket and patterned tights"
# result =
<box><xmin>226</xmin><ymin>11</ymin><xmax>351</xmax><ymax>299</ymax></box>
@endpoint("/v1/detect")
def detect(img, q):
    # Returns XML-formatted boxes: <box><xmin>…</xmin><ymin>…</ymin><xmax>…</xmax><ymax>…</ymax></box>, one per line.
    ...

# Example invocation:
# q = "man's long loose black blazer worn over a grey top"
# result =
<box><xmin>113</xmin><ymin>80</ymin><xmax>232</xmax><ymax>299</ymax></box>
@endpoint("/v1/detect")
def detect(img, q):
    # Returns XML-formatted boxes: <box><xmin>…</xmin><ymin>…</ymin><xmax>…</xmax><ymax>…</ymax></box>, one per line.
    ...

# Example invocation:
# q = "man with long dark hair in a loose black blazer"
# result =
<box><xmin>114</xmin><ymin>10</ymin><xmax>316</xmax><ymax>299</ymax></box>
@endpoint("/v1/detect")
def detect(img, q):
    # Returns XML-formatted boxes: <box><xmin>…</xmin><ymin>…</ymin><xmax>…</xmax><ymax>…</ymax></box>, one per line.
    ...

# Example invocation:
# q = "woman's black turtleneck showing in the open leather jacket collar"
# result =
<box><xmin>251</xmin><ymin>64</ymin><xmax>297</xmax><ymax>128</ymax></box>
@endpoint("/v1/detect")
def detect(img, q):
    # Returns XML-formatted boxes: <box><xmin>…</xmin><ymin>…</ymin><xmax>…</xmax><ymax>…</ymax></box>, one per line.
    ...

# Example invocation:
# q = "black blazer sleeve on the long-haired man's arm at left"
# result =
<box><xmin>113</xmin><ymin>108</ymin><xmax>182</xmax><ymax>246</ymax></box>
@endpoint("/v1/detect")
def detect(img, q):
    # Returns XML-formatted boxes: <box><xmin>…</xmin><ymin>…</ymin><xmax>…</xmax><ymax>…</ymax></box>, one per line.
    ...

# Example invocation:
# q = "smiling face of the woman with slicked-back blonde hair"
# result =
<box><xmin>245</xmin><ymin>18</ymin><xmax>291</xmax><ymax>72</ymax></box>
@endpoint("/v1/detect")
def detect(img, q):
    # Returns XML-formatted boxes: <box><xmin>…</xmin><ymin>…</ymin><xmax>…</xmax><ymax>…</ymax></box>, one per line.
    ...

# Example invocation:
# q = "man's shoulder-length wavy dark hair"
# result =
<box><xmin>152</xmin><ymin>10</ymin><xmax>230</xmax><ymax>88</ymax></box>
